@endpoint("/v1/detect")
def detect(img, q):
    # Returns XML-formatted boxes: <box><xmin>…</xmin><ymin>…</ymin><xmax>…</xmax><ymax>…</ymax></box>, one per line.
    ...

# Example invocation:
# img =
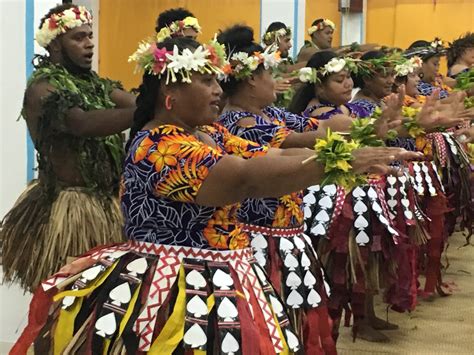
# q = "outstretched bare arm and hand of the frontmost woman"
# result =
<box><xmin>196</xmin><ymin>147</ymin><xmax>420</xmax><ymax>206</ymax></box>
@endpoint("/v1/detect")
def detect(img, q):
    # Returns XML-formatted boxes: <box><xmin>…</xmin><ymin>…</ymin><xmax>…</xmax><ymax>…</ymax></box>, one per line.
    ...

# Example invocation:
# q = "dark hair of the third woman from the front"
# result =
<box><xmin>288</xmin><ymin>51</ymin><xmax>337</xmax><ymax>114</ymax></box>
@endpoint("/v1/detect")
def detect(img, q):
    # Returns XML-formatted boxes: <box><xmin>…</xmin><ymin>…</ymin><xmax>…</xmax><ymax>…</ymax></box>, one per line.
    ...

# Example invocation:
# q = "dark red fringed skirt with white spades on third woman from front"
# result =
<box><xmin>304</xmin><ymin>179</ymin><xmax>403</xmax><ymax>322</ymax></box>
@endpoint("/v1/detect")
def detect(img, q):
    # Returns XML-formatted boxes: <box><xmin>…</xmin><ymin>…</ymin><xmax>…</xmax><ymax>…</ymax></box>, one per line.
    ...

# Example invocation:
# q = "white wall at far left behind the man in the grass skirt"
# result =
<box><xmin>0</xmin><ymin>0</ymin><xmax>59</xmax><ymax>354</ymax></box>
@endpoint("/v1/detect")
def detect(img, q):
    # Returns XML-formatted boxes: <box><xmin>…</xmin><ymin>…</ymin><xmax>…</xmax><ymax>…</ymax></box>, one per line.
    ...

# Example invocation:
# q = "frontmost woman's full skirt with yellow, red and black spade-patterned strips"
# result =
<box><xmin>12</xmin><ymin>241</ymin><xmax>302</xmax><ymax>354</ymax></box>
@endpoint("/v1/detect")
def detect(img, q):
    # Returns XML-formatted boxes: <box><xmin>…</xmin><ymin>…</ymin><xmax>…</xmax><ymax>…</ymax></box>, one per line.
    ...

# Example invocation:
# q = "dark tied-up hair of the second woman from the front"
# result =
<box><xmin>217</xmin><ymin>25</ymin><xmax>263</xmax><ymax>96</ymax></box>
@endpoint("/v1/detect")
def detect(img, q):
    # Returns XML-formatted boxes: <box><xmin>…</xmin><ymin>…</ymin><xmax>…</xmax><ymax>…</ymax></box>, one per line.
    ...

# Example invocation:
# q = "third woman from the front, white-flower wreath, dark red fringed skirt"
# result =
<box><xmin>290</xmin><ymin>51</ymin><xmax>410</xmax><ymax>342</ymax></box>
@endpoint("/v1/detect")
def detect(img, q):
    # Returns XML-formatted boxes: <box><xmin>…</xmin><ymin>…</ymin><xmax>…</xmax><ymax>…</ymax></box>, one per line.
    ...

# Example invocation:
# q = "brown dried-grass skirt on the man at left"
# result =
<box><xmin>0</xmin><ymin>182</ymin><xmax>124</xmax><ymax>290</ymax></box>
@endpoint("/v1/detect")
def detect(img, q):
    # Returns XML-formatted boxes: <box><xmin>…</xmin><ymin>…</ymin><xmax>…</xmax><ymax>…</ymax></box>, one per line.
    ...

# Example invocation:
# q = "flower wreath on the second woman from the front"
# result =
<box><xmin>222</xmin><ymin>47</ymin><xmax>281</xmax><ymax>81</ymax></box>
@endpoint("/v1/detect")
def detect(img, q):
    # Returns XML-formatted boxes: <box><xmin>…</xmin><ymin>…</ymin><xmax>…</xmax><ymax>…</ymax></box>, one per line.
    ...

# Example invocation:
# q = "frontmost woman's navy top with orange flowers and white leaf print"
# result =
<box><xmin>120</xmin><ymin>125</ymin><xmax>268</xmax><ymax>249</ymax></box>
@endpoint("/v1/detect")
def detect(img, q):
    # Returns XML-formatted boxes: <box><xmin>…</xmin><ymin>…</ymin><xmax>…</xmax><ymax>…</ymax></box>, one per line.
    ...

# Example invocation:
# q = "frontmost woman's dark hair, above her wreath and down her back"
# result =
<box><xmin>126</xmin><ymin>37</ymin><xmax>200</xmax><ymax>149</ymax></box>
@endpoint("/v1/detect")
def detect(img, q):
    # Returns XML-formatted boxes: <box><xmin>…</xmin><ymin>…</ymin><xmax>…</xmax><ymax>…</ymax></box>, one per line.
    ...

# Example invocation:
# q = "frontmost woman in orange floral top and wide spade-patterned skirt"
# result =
<box><xmin>12</xmin><ymin>38</ymin><xmax>416</xmax><ymax>354</ymax></box>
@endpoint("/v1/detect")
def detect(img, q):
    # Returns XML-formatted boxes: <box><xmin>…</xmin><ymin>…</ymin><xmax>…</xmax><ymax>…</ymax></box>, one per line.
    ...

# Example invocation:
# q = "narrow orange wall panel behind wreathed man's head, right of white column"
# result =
<box><xmin>305</xmin><ymin>0</ymin><xmax>341</xmax><ymax>46</ymax></box>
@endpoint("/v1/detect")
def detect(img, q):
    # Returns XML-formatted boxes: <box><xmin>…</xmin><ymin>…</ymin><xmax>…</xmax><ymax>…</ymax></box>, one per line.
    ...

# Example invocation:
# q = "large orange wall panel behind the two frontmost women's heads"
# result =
<box><xmin>99</xmin><ymin>0</ymin><xmax>260</xmax><ymax>89</ymax></box>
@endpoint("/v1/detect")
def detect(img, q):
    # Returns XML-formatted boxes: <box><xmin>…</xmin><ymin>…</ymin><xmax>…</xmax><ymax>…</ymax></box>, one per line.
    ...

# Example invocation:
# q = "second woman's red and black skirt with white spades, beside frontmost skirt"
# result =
<box><xmin>242</xmin><ymin>224</ymin><xmax>336</xmax><ymax>354</ymax></box>
